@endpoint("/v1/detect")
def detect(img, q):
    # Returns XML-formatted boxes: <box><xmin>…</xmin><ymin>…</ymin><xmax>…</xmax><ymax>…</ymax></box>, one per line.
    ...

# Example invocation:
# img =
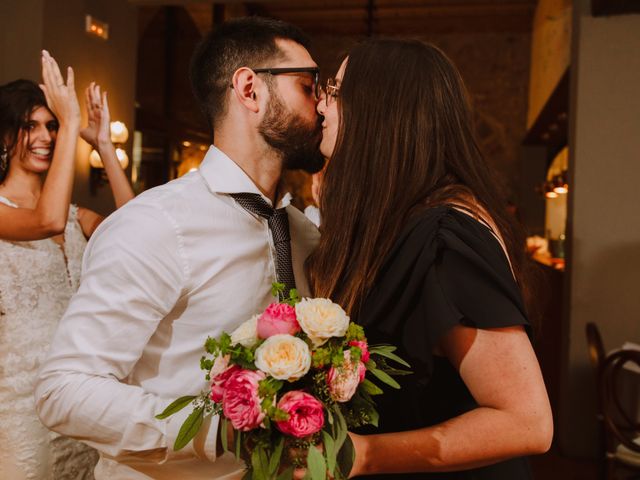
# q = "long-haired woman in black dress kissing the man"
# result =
<box><xmin>308</xmin><ymin>40</ymin><xmax>553</xmax><ymax>480</ymax></box>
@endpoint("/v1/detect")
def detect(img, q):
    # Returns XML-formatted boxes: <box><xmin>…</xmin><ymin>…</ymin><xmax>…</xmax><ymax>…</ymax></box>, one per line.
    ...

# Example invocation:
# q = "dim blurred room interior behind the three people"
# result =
<box><xmin>0</xmin><ymin>0</ymin><xmax>640</xmax><ymax>479</ymax></box>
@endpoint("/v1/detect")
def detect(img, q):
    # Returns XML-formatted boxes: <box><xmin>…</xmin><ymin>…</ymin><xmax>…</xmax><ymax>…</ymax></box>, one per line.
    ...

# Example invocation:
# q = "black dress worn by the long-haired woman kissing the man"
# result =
<box><xmin>357</xmin><ymin>206</ymin><xmax>533</xmax><ymax>480</ymax></box>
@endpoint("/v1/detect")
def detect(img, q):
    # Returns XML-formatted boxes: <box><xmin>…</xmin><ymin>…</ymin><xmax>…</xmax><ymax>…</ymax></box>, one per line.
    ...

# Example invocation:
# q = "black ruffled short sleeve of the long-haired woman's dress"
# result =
<box><xmin>357</xmin><ymin>207</ymin><xmax>529</xmax><ymax>375</ymax></box>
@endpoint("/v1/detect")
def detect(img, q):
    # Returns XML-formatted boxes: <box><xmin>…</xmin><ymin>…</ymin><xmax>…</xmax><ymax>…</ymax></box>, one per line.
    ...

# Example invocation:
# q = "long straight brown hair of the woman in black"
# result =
<box><xmin>307</xmin><ymin>39</ymin><xmax>524</xmax><ymax>315</ymax></box>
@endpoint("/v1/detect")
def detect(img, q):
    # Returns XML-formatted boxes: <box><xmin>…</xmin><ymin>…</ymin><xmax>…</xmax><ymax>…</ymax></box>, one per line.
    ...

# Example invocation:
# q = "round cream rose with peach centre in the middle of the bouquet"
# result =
<box><xmin>256</xmin><ymin>333</ymin><xmax>311</xmax><ymax>382</ymax></box>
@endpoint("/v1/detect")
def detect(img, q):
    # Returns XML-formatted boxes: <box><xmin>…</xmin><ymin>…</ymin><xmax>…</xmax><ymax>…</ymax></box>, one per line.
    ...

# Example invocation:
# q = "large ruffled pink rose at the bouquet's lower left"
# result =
<box><xmin>222</xmin><ymin>369</ymin><xmax>266</xmax><ymax>432</ymax></box>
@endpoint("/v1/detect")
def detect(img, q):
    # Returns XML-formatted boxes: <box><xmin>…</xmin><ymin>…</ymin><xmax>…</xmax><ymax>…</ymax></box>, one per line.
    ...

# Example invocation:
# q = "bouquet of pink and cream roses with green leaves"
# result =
<box><xmin>157</xmin><ymin>283</ymin><xmax>411</xmax><ymax>480</ymax></box>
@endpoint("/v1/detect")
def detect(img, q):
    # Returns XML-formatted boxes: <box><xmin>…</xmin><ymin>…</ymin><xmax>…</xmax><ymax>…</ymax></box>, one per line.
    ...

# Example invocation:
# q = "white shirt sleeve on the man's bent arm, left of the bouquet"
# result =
<box><xmin>35</xmin><ymin>203</ymin><xmax>217</xmax><ymax>462</ymax></box>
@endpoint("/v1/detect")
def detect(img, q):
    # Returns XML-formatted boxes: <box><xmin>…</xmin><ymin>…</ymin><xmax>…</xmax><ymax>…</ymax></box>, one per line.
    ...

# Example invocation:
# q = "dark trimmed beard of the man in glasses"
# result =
<box><xmin>259</xmin><ymin>91</ymin><xmax>324</xmax><ymax>173</ymax></box>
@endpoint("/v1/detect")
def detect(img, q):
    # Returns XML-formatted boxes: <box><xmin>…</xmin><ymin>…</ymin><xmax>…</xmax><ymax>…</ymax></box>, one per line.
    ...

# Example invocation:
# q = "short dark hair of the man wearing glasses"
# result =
<box><xmin>189</xmin><ymin>17</ymin><xmax>309</xmax><ymax>128</ymax></box>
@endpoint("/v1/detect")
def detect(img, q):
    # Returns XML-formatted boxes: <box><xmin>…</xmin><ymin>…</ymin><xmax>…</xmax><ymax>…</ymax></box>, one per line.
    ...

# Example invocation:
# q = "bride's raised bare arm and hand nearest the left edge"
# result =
<box><xmin>0</xmin><ymin>50</ymin><xmax>80</xmax><ymax>241</ymax></box>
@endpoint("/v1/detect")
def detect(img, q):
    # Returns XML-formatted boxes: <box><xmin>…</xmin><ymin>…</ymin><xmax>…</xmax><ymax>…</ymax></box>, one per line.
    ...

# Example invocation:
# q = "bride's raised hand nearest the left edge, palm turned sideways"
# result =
<box><xmin>40</xmin><ymin>50</ymin><xmax>80</xmax><ymax>127</ymax></box>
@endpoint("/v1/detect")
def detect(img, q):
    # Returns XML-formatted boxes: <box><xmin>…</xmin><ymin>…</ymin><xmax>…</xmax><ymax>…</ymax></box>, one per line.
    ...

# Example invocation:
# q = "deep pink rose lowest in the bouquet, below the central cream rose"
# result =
<box><xmin>276</xmin><ymin>390</ymin><xmax>324</xmax><ymax>438</ymax></box>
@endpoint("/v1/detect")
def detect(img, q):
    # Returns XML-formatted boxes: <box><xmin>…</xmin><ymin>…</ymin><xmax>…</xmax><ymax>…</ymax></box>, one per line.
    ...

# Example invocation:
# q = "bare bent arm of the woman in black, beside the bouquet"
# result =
<box><xmin>351</xmin><ymin>326</ymin><xmax>553</xmax><ymax>476</ymax></box>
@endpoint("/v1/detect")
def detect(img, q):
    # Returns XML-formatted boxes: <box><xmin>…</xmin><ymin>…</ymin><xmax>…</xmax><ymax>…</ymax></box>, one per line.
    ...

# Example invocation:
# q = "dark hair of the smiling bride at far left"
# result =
<box><xmin>0</xmin><ymin>80</ymin><xmax>53</xmax><ymax>183</ymax></box>
